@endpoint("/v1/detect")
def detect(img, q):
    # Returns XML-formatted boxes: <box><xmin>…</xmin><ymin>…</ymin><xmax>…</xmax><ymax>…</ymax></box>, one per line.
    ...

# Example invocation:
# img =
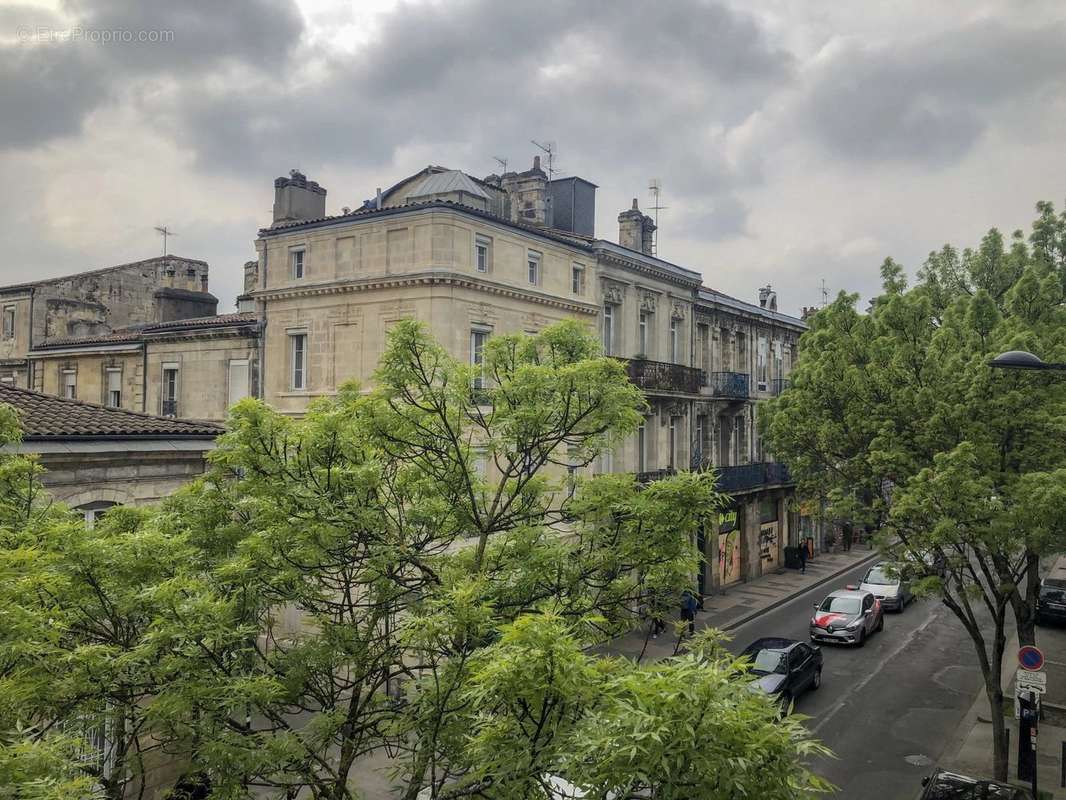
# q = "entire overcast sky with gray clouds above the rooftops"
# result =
<box><xmin>0</xmin><ymin>0</ymin><xmax>1066</xmax><ymax>320</ymax></box>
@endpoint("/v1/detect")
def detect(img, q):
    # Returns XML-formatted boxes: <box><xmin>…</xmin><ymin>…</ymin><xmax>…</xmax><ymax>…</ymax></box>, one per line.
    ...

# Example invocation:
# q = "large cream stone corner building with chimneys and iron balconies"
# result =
<box><xmin>246</xmin><ymin>159</ymin><xmax>817</xmax><ymax>592</ymax></box>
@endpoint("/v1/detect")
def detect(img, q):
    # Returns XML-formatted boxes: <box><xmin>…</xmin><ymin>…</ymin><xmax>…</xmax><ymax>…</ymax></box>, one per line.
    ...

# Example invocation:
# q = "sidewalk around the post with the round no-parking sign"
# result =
<box><xmin>940</xmin><ymin>557</ymin><xmax>1066</xmax><ymax>800</ymax></box>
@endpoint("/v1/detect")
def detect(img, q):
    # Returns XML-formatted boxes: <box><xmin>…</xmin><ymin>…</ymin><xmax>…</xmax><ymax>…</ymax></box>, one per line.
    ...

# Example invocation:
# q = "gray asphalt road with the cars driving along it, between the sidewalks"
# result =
<box><xmin>730</xmin><ymin>566</ymin><xmax>982</xmax><ymax>800</ymax></box>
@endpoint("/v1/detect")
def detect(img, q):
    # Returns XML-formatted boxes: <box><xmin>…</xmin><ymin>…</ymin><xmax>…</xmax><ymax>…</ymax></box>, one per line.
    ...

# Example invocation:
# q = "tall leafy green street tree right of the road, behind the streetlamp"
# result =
<box><xmin>760</xmin><ymin>205</ymin><xmax>1066</xmax><ymax>778</ymax></box>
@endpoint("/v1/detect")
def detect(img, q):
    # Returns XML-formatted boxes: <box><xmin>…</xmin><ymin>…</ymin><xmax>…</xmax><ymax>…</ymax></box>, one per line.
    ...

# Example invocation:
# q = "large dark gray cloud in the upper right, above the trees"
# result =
<box><xmin>797</xmin><ymin>20</ymin><xmax>1066</xmax><ymax>166</ymax></box>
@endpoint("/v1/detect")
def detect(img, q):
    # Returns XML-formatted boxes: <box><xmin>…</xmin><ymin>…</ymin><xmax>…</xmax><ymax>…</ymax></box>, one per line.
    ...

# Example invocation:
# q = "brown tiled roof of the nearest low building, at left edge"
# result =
<box><xmin>0</xmin><ymin>384</ymin><xmax>223</xmax><ymax>442</ymax></box>
